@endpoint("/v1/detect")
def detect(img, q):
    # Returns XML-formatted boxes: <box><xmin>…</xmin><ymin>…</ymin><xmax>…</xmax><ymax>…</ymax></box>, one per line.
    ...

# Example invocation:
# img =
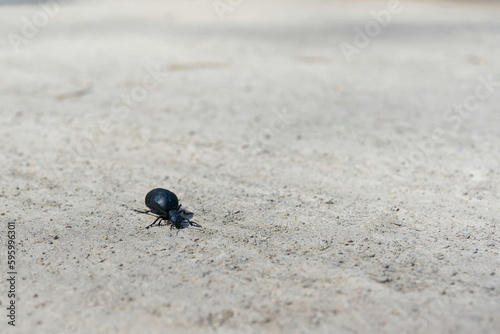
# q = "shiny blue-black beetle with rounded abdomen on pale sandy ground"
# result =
<box><xmin>134</xmin><ymin>188</ymin><xmax>201</xmax><ymax>229</ymax></box>
